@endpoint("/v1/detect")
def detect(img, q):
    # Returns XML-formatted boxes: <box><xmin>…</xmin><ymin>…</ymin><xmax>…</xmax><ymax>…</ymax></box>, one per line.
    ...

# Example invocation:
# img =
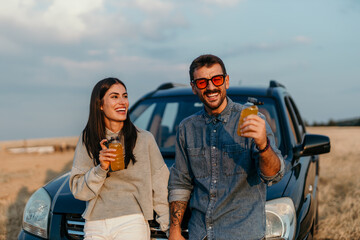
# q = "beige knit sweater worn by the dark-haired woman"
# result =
<box><xmin>69</xmin><ymin>129</ymin><xmax>169</xmax><ymax>231</ymax></box>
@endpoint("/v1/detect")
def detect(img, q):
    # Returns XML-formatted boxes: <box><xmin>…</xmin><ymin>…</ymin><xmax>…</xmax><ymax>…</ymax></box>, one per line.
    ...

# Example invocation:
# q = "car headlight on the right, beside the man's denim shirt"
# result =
<box><xmin>265</xmin><ymin>197</ymin><xmax>296</xmax><ymax>240</ymax></box>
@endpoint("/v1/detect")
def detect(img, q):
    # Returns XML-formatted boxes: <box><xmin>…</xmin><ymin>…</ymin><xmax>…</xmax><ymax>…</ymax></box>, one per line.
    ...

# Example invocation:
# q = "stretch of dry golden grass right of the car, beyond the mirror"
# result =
<box><xmin>308</xmin><ymin>127</ymin><xmax>360</xmax><ymax>239</ymax></box>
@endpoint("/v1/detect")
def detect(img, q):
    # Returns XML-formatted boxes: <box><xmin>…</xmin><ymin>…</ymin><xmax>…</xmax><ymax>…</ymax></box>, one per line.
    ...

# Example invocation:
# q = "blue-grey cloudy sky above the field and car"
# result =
<box><xmin>0</xmin><ymin>0</ymin><xmax>360</xmax><ymax>141</ymax></box>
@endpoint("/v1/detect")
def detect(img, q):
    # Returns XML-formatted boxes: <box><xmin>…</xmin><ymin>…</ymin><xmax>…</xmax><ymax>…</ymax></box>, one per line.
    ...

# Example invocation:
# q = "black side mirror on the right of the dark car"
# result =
<box><xmin>294</xmin><ymin>134</ymin><xmax>330</xmax><ymax>157</ymax></box>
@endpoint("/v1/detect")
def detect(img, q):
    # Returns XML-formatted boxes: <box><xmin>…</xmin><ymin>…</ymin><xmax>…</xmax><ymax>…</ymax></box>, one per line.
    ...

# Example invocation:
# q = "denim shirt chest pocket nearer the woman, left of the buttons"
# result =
<box><xmin>187</xmin><ymin>148</ymin><xmax>210</xmax><ymax>178</ymax></box>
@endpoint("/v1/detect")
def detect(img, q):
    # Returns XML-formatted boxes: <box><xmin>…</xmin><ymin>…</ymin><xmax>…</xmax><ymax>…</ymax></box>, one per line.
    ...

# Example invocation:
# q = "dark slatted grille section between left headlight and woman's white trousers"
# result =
<box><xmin>65</xmin><ymin>214</ymin><xmax>85</xmax><ymax>240</ymax></box>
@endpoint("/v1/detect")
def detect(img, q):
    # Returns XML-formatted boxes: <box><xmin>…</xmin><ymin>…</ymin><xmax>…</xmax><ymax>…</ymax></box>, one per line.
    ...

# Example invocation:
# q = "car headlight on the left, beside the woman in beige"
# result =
<box><xmin>23</xmin><ymin>188</ymin><xmax>51</xmax><ymax>238</ymax></box>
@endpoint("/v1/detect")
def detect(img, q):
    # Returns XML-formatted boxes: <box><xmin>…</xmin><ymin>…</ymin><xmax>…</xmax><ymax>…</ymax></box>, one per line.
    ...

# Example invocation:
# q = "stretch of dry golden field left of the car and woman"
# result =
<box><xmin>0</xmin><ymin>138</ymin><xmax>77</xmax><ymax>240</ymax></box>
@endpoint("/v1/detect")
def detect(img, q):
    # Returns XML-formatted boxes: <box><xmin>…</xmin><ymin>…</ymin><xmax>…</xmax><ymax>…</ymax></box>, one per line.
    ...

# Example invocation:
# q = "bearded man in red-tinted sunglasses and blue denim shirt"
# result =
<box><xmin>168</xmin><ymin>55</ymin><xmax>284</xmax><ymax>240</ymax></box>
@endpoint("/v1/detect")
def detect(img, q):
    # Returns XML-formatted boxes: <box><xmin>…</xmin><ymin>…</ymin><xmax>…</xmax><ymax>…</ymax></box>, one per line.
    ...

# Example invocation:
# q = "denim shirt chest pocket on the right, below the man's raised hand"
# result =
<box><xmin>222</xmin><ymin>144</ymin><xmax>251</xmax><ymax>176</ymax></box>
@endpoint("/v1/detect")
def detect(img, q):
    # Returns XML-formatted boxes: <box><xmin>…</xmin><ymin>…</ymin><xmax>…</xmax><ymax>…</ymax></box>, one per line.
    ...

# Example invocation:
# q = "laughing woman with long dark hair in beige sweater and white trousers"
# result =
<box><xmin>70</xmin><ymin>78</ymin><xmax>169</xmax><ymax>240</ymax></box>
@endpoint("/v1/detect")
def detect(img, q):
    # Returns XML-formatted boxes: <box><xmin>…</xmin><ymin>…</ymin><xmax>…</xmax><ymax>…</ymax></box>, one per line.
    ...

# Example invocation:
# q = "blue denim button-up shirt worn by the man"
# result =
<box><xmin>168</xmin><ymin>98</ymin><xmax>284</xmax><ymax>240</ymax></box>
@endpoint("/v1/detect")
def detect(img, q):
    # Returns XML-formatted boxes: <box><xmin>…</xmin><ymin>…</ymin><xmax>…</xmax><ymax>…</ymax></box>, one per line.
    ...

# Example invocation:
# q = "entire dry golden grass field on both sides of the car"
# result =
<box><xmin>0</xmin><ymin>127</ymin><xmax>360</xmax><ymax>240</ymax></box>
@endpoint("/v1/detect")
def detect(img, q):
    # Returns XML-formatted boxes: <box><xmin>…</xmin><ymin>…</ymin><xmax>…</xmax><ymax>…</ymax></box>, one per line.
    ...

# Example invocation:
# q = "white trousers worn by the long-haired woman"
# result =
<box><xmin>84</xmin><ymin>214</ymin><xmax>150</xmax><ymax>240</ymax></box>
